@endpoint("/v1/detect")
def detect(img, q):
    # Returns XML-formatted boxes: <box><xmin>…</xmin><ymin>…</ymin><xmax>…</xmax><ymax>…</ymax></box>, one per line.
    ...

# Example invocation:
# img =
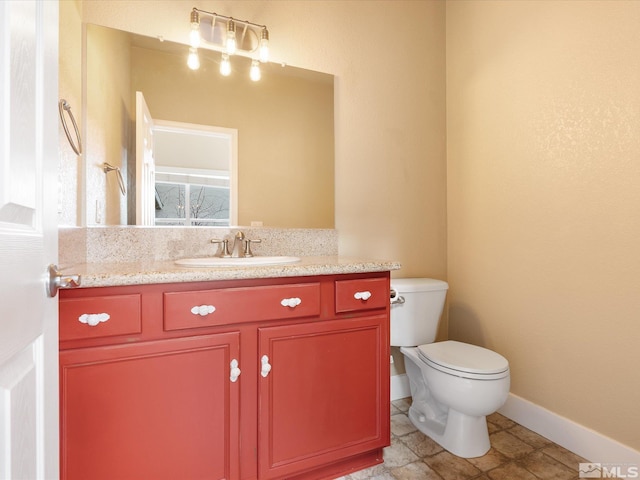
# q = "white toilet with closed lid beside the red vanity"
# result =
<box><xmin>391</xmin><ymin>278</ymin><xmax>510</xmax><ymax>458</ymax></box>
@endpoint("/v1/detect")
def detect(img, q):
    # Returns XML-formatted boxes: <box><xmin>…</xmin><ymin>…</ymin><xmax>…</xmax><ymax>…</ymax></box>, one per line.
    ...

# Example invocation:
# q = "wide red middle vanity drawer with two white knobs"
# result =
<box><xmin>164</xmin><ymin>283</ymin><xmax>320</xmax><ymax>331</ymax></box>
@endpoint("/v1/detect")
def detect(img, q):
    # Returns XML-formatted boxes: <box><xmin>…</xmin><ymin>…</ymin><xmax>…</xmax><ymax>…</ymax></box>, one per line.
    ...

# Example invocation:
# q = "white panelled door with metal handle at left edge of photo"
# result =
<box><xmin>0</xmin><ymin>0</ymin><xmax>59</xmax><ymax>480</ymax></box>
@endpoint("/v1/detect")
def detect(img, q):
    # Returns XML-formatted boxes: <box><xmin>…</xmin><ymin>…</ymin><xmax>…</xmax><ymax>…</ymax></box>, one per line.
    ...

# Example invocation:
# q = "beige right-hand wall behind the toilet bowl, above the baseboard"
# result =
<box><xmin>446</xmin><ymin>0</ymin><xmax>640</xmax><ymax>449</ymax></box>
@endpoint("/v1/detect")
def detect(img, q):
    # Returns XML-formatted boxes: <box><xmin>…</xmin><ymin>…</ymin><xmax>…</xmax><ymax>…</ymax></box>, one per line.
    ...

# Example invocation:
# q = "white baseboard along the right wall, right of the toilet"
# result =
<box><xmin>500</xmin><ymin>394</ymin><xmax>640</xmax><ymax>466</ymax></box>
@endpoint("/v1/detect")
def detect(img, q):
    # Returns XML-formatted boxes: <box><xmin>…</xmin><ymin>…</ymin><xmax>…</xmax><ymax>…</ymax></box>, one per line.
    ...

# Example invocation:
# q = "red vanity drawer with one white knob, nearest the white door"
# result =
<box><xmin>59</xmin><ymin>294</ymin><xmax>142</xmax><ymax>341</ymax></box>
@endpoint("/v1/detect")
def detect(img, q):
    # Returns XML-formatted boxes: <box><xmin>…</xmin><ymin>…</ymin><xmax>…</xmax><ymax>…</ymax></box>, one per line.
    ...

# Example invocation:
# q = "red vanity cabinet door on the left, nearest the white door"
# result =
<box><xmin>60</xmin><ymin>332</ymin><xmax>241</xmax><ymax>480</ymax></box>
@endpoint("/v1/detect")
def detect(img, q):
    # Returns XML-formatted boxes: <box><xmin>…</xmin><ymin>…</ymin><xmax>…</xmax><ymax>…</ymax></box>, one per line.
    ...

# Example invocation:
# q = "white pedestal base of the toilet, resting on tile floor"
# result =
<box><xmin>409</xmin><ymin>405</ymin><xmax>491</xmax><ymax>458</ymax></box>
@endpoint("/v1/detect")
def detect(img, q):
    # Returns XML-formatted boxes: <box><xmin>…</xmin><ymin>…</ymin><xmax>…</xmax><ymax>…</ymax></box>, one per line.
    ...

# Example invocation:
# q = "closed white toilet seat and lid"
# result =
<box><xmin>418</xmin><ymin>340</ymin><xmax>509</xmax><ymax>380</ymax></box>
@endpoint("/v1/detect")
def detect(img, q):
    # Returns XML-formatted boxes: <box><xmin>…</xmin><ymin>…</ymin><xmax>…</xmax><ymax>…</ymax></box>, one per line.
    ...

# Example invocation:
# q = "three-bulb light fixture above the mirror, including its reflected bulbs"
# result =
<box><xmin>187</xmin><ymin>7</ymin><xmax>269</xmax><ymax>81</ymax></box>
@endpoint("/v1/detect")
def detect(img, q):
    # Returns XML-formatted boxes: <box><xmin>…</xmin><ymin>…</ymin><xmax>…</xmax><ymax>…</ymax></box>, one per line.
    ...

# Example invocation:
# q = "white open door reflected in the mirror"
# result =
<box><xmin>136</xmin><ymin>92</ymin><xmax>156</xmax><ymax>225</ymax></box>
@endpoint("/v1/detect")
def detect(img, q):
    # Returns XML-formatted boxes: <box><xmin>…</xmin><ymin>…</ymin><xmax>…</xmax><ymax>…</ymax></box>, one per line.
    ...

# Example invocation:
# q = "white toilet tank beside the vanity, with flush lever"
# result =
<box><xmin>391</xmin><ymin>278</ymin><xmax>449</xmax><ymax>347</ymax></box>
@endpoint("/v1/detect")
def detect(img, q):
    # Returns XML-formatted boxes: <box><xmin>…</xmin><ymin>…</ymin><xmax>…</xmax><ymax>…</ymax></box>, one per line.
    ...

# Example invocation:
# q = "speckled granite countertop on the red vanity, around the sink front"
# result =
<box><xmin>62</xmin><ymin>256</ymin><xmax>401</xmax><ymax>288</ymax></box>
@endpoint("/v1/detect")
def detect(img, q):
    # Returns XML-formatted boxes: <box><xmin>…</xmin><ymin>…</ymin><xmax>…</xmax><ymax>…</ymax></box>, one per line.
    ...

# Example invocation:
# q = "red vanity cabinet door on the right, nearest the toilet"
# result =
<box><xmin>258</xmin><ymin>314</ymin><xmax>389</xmax><ymax>480</ymax></box>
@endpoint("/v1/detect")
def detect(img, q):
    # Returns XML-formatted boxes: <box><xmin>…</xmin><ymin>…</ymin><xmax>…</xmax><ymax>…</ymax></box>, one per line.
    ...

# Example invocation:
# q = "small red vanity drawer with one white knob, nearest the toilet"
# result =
<box><xmin>336</xmin><ymin>278</ymin><xmax>391</xmax><ymax>313</ymax></box>
